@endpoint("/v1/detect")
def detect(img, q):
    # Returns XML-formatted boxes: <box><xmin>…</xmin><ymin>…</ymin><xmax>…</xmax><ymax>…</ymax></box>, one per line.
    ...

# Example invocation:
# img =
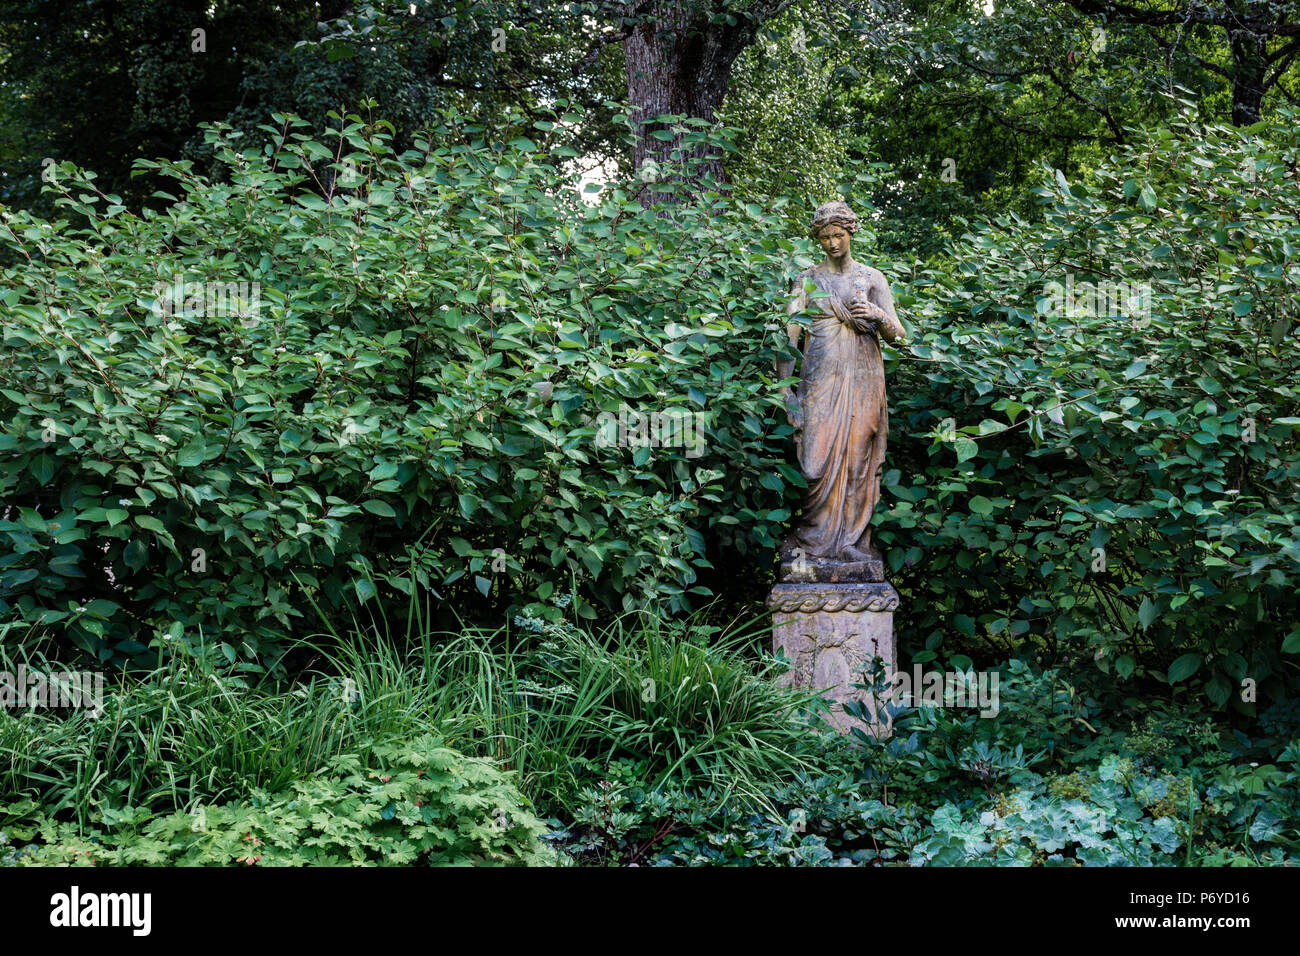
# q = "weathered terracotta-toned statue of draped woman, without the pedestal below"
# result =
<box><xmin>776</xmin><ymin>200</ymin><xmax>906</xmax><ymax>580</ymax></box>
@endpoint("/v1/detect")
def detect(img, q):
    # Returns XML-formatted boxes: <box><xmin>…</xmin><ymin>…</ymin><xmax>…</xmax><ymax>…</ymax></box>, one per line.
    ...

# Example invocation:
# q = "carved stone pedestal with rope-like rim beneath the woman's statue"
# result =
<box><xmin>767</xmin><ymin>566</ymin><xmax>898</xmax><ymax>737</ymax></box>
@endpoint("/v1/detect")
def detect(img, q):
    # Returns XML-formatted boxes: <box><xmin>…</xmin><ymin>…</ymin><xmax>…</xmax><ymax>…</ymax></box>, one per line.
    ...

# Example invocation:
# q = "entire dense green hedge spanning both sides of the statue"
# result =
<box><xmin>0</xmin><ymin>108</ymin><xmax>1300</xmax><ymax>710</ymax></box>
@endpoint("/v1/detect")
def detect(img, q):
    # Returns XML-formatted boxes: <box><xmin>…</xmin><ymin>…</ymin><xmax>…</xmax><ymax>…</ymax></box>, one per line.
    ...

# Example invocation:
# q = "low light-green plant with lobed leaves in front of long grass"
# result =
<box><xmin>1</xmin><ymin>735</ymin><xmax>555</xmax><ymax>866</ymax></box>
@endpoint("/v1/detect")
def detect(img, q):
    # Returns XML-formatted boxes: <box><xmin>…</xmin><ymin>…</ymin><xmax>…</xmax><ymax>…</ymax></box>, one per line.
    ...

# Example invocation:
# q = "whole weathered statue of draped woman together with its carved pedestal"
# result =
<box><xmin>767</xmin><ymin>202</ymin><xmax>906</xmax><ymax>736</ymax></box>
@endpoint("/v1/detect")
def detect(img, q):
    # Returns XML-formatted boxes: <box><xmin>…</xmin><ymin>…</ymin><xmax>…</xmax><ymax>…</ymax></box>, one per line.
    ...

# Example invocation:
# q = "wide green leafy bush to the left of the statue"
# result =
<box><xmin>0</xmin><ymin>104</ymin><xmax>810</xmax><ymax>666</ymax></box>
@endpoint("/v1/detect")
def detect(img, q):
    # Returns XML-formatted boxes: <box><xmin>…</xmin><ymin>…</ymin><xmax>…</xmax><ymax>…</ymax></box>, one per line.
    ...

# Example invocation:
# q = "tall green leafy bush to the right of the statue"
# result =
<box><xmin>876</xmin><ymin>113</ymin><xmax>1300</xmax><ymax>714</ymax></box>
